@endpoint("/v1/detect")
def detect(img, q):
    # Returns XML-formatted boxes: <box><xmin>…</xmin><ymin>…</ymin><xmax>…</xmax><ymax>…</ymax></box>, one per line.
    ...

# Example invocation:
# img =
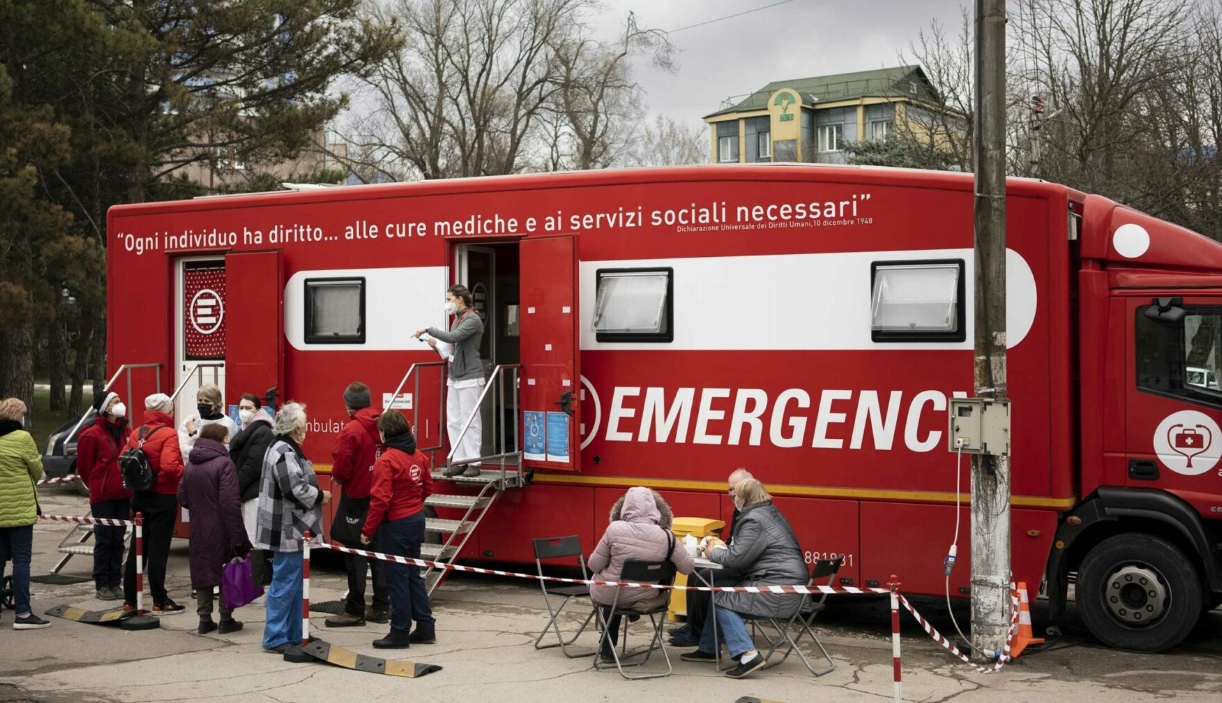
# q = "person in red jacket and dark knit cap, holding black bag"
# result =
<box><xmin>324</xmin><ymin>381</ymin><xmax>390</xmax><ymax>627</ymax></box>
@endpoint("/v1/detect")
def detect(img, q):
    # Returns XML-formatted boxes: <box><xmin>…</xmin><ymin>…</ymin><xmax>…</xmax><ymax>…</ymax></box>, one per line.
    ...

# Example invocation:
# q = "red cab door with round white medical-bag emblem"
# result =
<box><xmin>1124</xmin><ymin>296</ymin><xmax>1222</xmax><ymax>491</ymax></box>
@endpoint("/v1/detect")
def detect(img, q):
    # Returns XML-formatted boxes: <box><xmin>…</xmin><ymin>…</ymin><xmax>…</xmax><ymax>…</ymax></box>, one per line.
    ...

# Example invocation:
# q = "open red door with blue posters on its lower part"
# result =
<box><xmin>519</xmin><ymin>235</ymin><xmax>582</xmax><ymax>471</ymax></box>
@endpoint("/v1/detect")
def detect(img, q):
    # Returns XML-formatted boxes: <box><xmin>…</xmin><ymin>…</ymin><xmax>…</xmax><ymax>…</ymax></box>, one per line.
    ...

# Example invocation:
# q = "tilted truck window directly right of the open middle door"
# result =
<box><xmin>594</xmin><ymin>268</ymin><xmax>675</xmax><ymax>342</ymax></box>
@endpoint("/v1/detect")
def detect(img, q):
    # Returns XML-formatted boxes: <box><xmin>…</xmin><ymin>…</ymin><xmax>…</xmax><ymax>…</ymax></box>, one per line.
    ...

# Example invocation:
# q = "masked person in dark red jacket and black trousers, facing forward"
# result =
<box><xmin>77</xmin><ymin>392</ymin><xmax>132</xmax><ymax>600</ymax></box>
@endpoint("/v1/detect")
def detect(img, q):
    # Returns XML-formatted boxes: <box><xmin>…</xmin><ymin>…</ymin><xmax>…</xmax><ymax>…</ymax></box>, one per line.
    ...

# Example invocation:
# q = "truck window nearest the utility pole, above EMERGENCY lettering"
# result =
<box><xmin>870</xmin><ymin>259</ymin><xmax>967</xmax><ymax>342</ymax></box>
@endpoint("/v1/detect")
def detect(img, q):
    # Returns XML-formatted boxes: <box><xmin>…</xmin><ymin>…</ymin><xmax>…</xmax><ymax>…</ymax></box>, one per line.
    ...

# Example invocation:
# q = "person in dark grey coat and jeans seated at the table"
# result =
<box><xmin>681</xmin><ymin>478</ymin><xmax>810</xmax><ymax>679</ymax></box>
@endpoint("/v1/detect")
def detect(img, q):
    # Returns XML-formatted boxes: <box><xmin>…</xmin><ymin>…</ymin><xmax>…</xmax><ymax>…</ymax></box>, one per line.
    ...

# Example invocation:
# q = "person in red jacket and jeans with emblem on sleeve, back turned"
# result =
<box><xmin>360</xmin><ymin>410</ymin><xmax>437</xmax><ymax>649</ymax></box>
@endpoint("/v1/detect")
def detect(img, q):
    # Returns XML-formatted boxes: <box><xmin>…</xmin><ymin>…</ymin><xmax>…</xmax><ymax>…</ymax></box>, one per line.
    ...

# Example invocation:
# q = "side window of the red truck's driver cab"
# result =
<box><xmin>1135</xmin><ymin>307</ymin><xmax>1222</xmax><ymax>406</ymax></box>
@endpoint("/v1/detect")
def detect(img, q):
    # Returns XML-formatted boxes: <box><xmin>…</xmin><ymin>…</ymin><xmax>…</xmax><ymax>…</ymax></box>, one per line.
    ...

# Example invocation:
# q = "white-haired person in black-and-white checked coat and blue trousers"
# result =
<box><xmin>254</xmin><ymin>402</ymin><xmax>331</xmax><ymax>654</ymax></box>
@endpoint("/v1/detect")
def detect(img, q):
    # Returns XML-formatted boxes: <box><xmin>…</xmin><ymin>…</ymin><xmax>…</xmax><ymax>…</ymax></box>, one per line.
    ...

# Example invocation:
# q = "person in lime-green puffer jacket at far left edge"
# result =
<box><xmin>0</xmin><ymin>397</ymin><xmax>51</xmax><ymax>630</ymax></box>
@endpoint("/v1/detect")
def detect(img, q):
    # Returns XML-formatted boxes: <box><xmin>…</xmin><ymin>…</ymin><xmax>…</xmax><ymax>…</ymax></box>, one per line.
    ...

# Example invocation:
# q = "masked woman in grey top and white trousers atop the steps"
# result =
<box><xmin>412</xmin><ymin>285</ymin><xmax>484</xmax><ymax>477</ymax></box>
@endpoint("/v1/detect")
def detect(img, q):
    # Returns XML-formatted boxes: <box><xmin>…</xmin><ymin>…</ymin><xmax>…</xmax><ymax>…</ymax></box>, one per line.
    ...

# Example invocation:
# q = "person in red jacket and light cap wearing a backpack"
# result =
<box><xmin>123</xmin><ymin>392</ymin><xmax>186</xmax><ymax>615</ymax></box>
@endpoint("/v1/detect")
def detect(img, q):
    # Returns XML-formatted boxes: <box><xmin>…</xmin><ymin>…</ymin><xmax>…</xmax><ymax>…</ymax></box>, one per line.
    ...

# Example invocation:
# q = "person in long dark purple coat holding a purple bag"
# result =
<box><xmin>178</xmin><ymin>423</ymin><xmax>251</xmax><ymax>635</ymax></box>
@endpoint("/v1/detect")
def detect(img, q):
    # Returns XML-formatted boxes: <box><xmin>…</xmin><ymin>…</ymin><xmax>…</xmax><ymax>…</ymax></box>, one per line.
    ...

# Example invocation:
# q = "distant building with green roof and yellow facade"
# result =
<box><xmin>704</xmin><ymin>66</ymin><xmax>942</xmax><ymax>164</ymax></box>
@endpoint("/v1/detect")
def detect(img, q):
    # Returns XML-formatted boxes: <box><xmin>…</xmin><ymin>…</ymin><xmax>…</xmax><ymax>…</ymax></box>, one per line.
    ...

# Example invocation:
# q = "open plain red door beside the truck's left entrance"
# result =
<box><xmin>225</xmin><ymin>252</ymin><xmax>285</xmax><ymax>422</ymax></box>
